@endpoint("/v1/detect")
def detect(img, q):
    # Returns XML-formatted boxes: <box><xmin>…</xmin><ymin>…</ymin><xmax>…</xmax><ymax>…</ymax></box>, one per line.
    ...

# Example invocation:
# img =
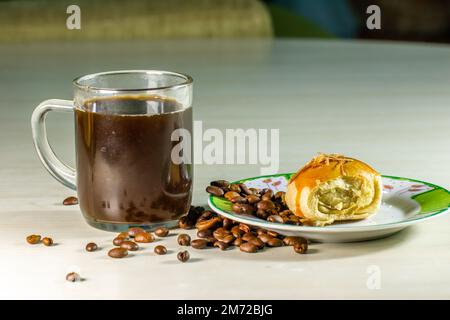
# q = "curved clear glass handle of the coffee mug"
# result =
<box><xmin>31</xmin><ymin>99</ymin><xmax>77</xmax><ymax>190</ymax></box>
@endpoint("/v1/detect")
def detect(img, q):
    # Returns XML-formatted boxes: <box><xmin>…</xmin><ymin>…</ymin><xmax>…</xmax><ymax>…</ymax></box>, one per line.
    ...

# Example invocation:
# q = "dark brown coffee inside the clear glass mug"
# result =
<box><xmin>75</xmin><ymin>96</ymin><xmax>192</xmax><ymax>224</ymax></box>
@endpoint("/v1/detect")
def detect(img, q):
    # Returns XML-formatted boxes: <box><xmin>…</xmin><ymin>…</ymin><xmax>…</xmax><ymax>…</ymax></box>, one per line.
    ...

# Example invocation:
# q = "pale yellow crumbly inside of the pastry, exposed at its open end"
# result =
<box><xmin>311</xmin><ymin>176</ymin><xmax>375</xmax><ymax>214</ymax></box>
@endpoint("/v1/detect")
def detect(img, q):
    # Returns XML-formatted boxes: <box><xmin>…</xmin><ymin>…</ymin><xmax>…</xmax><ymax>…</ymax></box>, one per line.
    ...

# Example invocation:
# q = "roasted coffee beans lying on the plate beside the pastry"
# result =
<box><xmin>206</xmin><ymin>180</ymin><xmax>302</xmax><ymax>226</ymax></box>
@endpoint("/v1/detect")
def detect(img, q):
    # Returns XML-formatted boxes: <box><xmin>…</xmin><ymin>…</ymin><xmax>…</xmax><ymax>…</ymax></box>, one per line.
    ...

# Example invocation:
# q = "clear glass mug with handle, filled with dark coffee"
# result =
<box><xmin>31</xmin><ymin>70</ymin><xmax>193</xmax><ymax>231</ymax></box>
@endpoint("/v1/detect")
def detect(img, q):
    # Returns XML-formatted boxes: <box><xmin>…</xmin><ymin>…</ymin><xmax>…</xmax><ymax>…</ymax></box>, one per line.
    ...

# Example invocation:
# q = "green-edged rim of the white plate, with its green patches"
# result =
<box><xmin>209</xmin><ymin>173</ymin><xmax>450</xmax><ymax>230</ymax></box>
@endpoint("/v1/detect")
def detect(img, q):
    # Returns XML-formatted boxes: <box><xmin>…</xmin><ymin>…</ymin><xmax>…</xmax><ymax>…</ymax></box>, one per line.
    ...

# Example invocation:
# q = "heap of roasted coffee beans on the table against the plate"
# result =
<box><xmin>178</xmin><ymin>202</ymin><xmax>308</xmax><ymax>255</ymax></box>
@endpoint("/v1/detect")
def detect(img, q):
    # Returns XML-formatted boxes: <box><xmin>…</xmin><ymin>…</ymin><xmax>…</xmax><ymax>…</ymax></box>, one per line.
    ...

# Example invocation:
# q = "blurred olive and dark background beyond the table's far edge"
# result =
<box><xmin>0</xmin><ymin>0</ymin><xmax>450</xmax><ymax>42</ymax></box>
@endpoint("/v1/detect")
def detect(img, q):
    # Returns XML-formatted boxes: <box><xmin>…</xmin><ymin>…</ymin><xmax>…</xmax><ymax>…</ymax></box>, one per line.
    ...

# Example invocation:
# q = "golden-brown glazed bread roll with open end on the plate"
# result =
<box><xmin>285</xmin><ymin>154</ymin><xmax>382</xmax><ymax>226</ymax></box>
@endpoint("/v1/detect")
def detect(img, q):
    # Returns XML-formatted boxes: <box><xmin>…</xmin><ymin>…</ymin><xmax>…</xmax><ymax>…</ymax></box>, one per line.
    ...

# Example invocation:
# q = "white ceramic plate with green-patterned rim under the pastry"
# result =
<box><xmin>208</xmin><ymin>174</ymin><xmax>450</xmax><ymax>242</ymax></box>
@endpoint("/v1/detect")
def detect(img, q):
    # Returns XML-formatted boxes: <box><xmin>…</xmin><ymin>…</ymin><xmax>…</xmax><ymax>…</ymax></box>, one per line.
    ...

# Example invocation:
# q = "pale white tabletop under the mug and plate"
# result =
<box><xmin>0</xmin><ymin>40</ymin><xmax>450</xmax><ymax>299</ymax></box>
